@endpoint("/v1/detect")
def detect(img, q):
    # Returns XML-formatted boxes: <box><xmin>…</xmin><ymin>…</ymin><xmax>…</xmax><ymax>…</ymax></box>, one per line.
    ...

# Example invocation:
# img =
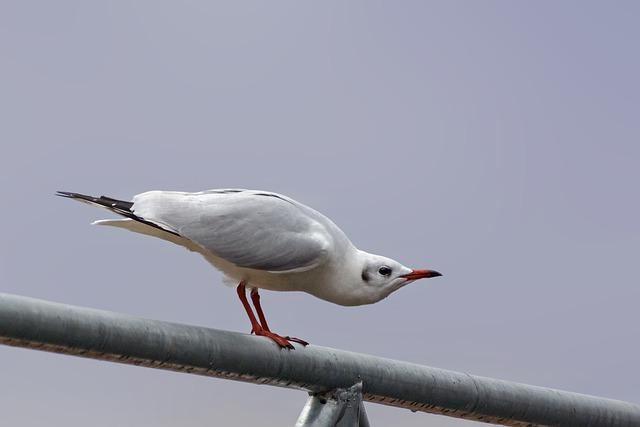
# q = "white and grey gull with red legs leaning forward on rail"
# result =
<box><xmin>56</xmin><ymin>189</ymin><xmax>441</xmax><ymax>349</ymax></box>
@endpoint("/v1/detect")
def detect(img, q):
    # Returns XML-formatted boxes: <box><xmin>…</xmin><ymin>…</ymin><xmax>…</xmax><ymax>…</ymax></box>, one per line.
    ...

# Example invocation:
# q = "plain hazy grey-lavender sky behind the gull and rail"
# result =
<box><xmin>0</xmin><ymin>1</ymin><xmax>640</xmax><ymax>427</ymax></box>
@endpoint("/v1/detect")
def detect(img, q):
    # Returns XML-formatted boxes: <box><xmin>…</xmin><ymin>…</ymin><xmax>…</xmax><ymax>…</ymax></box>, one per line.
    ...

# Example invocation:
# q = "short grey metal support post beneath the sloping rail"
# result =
<box><xmin>295</xmin><ymin>382</ymin><xmax>369</xmax><ymax>427</ymax></box>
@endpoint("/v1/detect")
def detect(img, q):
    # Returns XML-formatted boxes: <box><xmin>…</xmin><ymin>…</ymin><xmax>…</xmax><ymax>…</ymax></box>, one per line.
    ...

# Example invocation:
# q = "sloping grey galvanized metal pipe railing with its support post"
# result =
<box><xmin>0</xmin><ymin>294</ymin><xmax>640</xmax><ymax>427</ymax></box>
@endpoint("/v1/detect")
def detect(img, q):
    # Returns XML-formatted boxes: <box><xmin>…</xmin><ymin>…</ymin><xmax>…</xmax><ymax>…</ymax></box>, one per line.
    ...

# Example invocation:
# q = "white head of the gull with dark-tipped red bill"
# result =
<box><xmin>360</xmin><ymin>253</ymin><xmax>442</xmax><ymax>302</ymax></box>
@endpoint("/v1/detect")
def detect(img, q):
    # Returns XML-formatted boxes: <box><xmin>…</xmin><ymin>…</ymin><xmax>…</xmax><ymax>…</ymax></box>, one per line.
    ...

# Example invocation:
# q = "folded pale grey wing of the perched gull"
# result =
<box><xmin>133</xmin><ymin>190</ymin><xmax>331</xmax><ymax>271</ymax></box>
